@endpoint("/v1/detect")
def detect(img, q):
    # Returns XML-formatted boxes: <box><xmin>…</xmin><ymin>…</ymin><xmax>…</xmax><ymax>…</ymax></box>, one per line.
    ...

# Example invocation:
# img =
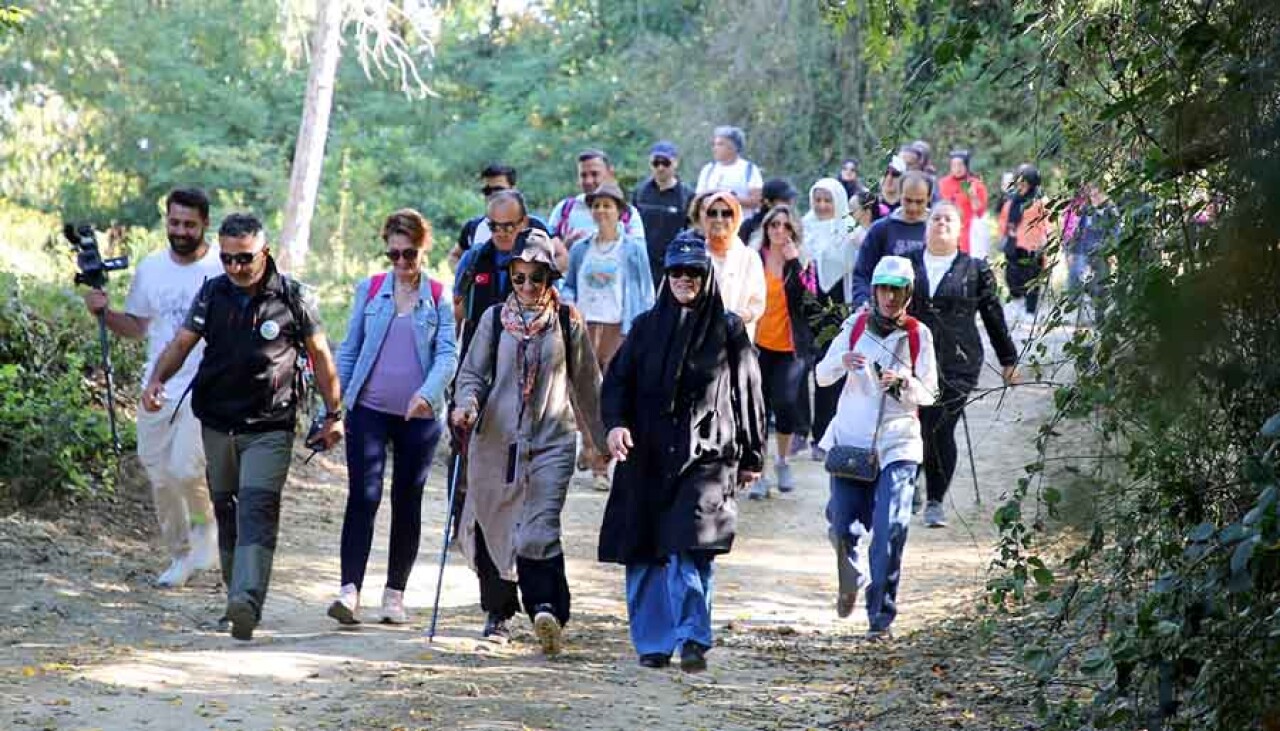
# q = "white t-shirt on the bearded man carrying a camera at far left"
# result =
<box><xmin>124</xmin><ymin>245</ymin><xmax>223</xmax><ymax>398</ymax></box>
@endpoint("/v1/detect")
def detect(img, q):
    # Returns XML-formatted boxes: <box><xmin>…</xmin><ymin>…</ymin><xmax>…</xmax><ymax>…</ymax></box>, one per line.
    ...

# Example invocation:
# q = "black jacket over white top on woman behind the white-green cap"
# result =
<box><xmin>908</xmin><ymin>251</ymin><xmax>1018</xmax><ymax>390</ymax></box>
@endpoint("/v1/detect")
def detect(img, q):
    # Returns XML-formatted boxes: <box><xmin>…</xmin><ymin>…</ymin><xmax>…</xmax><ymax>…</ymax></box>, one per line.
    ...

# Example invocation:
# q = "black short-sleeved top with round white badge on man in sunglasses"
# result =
<box><xmin>183</xmin><ymin>259</ymin><xmax>320</xmax><ymax>434</ymax></box>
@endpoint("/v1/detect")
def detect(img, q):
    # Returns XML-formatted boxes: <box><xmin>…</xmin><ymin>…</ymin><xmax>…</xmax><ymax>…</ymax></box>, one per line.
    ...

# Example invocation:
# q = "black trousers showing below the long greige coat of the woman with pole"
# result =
<box><xmin>476</xmin><ymin>524</ymin><xmax>570</xmax><ymax>626</ymax></box>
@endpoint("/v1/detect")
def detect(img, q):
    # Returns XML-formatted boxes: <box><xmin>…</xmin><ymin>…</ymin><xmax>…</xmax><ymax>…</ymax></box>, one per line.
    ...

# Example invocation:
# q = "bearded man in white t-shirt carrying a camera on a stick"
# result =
<box><xmin>84</xmin><ymin>188</ymin><xmax>223</xmax><ymax>588</ymax></box>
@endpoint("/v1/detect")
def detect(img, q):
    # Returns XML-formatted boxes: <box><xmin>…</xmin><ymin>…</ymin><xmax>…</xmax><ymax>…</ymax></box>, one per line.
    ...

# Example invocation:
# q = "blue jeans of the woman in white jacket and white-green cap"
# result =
<box><xmin>827</xmin><ymin>461</ymin><xmax>919</xmax><ymax>631</ymax></box>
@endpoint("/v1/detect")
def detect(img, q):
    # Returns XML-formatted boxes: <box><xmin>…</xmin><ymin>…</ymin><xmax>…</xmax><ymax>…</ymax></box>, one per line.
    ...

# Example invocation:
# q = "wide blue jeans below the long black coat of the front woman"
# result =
<box><xmin>627</xmin><ymin>552</ymin><xmax>714</xmax><ymax>655</ymax></box>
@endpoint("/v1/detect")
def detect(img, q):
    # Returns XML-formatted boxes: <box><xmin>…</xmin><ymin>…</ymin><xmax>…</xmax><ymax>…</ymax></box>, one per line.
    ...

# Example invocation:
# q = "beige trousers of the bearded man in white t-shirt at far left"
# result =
<box><xmin>137</xmin><ymin>394</ymin><xmax>216</xmax><ymax>557</ymax></box>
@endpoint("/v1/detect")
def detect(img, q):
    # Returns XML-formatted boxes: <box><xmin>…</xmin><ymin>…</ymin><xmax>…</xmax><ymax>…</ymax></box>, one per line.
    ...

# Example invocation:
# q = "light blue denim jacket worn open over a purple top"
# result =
<box><xmin>338</xmin><ymin>273</ymin><xmax>458</xmax><ymax>419</ymax></box>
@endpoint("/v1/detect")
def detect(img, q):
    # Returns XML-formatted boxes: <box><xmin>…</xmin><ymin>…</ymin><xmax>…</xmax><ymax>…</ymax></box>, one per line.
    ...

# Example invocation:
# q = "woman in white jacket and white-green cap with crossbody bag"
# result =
<box><xmin>815</xmin><ymin>256</ymin><xmax>938</xmax><ymax>639</ymax></box>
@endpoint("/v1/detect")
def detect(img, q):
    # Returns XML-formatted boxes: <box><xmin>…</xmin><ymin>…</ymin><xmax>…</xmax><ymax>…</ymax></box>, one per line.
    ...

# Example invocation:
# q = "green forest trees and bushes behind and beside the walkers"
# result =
<box><xmin>0</xmin><ymin>0</ymin><xmax>1280</xmax><ymax>731</ymax></box>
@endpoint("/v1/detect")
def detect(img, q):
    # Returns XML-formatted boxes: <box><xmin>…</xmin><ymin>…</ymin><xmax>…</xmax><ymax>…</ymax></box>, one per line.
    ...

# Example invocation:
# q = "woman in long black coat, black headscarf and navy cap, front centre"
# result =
<box><xmin>599</xmin><ymin>234</ymin><xmax>765</xmax><ymax>672</ymax></box>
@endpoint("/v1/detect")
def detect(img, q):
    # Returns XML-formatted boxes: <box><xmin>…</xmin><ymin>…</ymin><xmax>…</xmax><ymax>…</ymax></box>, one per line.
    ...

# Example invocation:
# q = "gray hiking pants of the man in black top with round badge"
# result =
<box><xmin>204</xmin><ymin>426</ymin><xmax>293</xmax><ymax>618</ymax></box>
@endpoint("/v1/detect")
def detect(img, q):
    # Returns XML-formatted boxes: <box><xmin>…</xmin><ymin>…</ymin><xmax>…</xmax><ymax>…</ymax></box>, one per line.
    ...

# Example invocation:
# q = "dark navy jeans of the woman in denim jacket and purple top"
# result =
<box><xmin>342</xmin><ymin>406</ymin><xmax>443</xmax><ymax>591</ymax></box>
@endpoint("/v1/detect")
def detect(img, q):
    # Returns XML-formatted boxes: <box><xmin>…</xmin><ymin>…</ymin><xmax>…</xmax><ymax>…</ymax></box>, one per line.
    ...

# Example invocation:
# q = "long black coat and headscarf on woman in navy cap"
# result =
<box><xmin>599</xmin><ymin>278</ymin><xmax>765</xmax><ymax>565</ymax></box>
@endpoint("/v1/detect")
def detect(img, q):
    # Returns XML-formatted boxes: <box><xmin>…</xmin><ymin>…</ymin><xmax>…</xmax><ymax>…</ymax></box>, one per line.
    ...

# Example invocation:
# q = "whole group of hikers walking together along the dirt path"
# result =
<box><xmin>86</xmin><ymin>127</ymin><xmax>1121</xmax><ymax>672</ymax></box>
